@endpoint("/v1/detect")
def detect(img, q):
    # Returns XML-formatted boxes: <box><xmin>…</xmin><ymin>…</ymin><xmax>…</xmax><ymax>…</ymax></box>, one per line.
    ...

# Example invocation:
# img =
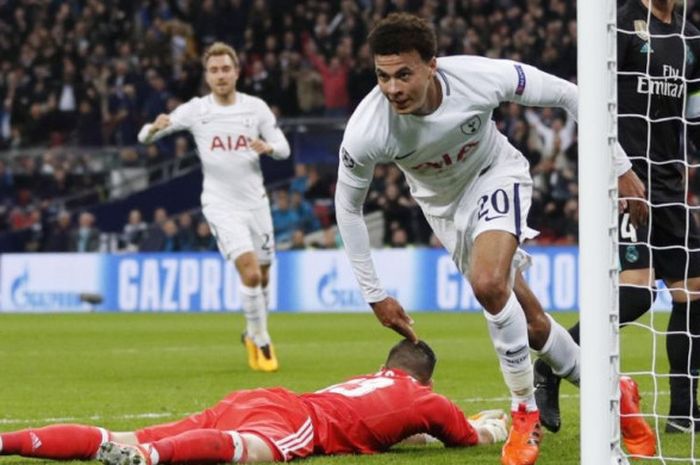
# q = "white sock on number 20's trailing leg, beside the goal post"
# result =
<box><xmin>535</xmin><ymin>314</ymin><xmax>581</xmax><ymax>386</ymax></box>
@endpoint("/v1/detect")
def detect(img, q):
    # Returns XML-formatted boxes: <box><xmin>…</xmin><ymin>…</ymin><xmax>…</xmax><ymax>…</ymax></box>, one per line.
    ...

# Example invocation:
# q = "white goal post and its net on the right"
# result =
<box><xmin>578</xmin><ymin>0</ymin><xmax>700</xmax><ymax>465</ymax></box>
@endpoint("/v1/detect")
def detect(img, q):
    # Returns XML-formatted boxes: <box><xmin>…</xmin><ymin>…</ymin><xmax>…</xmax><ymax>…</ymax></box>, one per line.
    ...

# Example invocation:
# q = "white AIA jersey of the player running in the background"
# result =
<box><xmin>139</xmin><ymin>92</ymin><xmax>290</xmax><ymax>210</ymax></box>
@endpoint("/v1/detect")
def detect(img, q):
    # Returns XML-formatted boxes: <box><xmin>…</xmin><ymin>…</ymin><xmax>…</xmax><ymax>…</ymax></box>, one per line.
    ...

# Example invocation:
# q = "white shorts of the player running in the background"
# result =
<box><xmin>202</xmin><ymin>202</ymin><xmax>275</xmax><ymax>265</ymax></box>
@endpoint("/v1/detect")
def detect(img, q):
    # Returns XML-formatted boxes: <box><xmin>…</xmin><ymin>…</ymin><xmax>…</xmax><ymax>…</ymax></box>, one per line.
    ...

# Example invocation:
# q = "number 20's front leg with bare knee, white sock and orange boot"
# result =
<box><xmin>469</xmin><ymin>230</ymin><xmax>541</xmax><ymax>465</ymax></box>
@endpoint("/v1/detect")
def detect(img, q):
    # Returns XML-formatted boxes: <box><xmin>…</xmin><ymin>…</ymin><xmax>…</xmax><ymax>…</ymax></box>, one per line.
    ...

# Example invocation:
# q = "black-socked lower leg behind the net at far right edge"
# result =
<box><xmin>666</xmin><ymin>278</ymin><xmax>700</xmax><ymax>433</ymax></box>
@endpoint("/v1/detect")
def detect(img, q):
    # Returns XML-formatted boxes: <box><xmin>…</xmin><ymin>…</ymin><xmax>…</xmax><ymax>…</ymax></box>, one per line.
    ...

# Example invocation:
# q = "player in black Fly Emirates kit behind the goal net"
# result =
<box><xmin>535</xmin><ymin>0</ymin><xmax>700</xmax><ymax>433</ymax></box>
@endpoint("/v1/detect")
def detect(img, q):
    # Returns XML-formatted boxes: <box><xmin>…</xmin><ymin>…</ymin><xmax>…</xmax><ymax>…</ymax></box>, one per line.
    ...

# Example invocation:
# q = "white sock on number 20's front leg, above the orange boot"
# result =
<box><xmin>484</xmin><ymin>292</ymin><xmax>537</xmax><ymax>411</ymax></box>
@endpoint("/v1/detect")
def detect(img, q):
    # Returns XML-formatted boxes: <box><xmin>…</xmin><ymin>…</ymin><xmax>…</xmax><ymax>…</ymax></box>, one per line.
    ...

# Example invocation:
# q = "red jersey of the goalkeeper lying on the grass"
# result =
<box><xmin>300</xmin><ymin>370</ymin><xmax>478</xmax><ymax>454</ymax></box>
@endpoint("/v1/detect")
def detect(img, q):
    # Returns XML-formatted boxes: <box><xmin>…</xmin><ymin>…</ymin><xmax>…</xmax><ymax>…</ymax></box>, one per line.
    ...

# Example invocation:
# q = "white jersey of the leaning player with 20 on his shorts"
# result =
<box><xmin>338</xmin><ymin>56</ymin><xmax>552</xmax><ymax>217</ymax></box>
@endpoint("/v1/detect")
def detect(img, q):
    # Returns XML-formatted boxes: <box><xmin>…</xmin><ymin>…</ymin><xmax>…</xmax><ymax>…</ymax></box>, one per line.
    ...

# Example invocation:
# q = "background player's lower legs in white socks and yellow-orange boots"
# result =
<box><xmin>234</xmin><ymin>252</ymin><xmax>279</xmax><ymax>372</ymax></box>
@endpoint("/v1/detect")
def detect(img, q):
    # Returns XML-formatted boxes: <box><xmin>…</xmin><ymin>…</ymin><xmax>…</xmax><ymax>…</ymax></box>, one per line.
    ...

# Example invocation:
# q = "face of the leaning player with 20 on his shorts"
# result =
<box><xmin>374</xmin><ymin>50</ymin><xmax>437</xmax><ymax>115</ymax></box>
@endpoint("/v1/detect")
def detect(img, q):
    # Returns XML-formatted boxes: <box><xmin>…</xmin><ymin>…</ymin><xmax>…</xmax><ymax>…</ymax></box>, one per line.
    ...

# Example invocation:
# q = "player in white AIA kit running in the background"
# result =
<box><xmin>139</xmin><ymin>42</ymin><xmax>290</xmax><ymax>371</ymax></box>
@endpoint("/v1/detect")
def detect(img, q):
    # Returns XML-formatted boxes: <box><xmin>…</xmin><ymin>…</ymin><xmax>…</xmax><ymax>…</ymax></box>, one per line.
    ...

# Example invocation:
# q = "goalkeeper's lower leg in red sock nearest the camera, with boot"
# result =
<box><xmin>97</xmin><ymin>429</ymin><xmax>276</xmax><ymax>465</ymax></box>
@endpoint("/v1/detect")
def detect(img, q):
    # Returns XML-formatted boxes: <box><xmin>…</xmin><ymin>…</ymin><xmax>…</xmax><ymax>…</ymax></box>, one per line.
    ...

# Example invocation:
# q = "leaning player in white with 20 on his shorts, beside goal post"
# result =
<box><xmin>335</xmin><ymin>14</ymin><xmax>643</xmax><ymax>465</ymax></box>
